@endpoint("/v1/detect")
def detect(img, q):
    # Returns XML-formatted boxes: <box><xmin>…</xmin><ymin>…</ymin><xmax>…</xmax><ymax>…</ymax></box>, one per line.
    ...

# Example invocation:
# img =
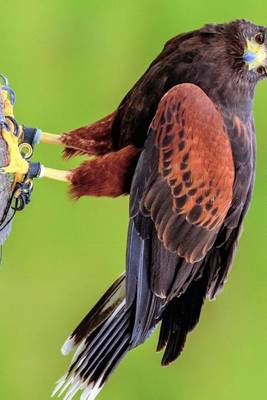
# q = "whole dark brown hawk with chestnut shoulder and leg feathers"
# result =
<box><xmin>1</xmin><ymin>20</ymin><xmax>267</xmax><ymax>400</ymax></box>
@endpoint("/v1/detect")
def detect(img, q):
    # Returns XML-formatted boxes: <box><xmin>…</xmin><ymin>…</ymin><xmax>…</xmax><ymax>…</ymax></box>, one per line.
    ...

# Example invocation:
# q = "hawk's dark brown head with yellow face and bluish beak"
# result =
<box><xmin>168</xmin><ymin>20</ymin><xmax>267</xmax><ymax>104</ymax></box>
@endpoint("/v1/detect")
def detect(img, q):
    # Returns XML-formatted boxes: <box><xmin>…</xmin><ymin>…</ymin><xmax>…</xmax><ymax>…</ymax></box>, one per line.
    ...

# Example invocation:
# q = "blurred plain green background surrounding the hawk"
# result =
<box><xmin>0</xmin><ymin>0</ymin><xmax>267</xmax><ymax>400</ymax></box>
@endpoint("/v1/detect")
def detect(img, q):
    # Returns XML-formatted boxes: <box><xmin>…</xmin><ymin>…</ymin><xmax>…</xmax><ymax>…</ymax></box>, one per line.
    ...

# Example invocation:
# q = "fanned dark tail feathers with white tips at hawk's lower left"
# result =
<box><xmin>52</xmin><ymin>275</ymin><xmax>132</xmax><ymax>400</ymax></box>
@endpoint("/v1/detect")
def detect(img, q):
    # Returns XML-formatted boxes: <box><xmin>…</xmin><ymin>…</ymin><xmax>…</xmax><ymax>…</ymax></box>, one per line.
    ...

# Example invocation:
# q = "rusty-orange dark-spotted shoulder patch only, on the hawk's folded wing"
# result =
<box><xmin>155</xmin><ymin>84</ymin><xmax>234</xmax><ymax>229</ymax></box>
